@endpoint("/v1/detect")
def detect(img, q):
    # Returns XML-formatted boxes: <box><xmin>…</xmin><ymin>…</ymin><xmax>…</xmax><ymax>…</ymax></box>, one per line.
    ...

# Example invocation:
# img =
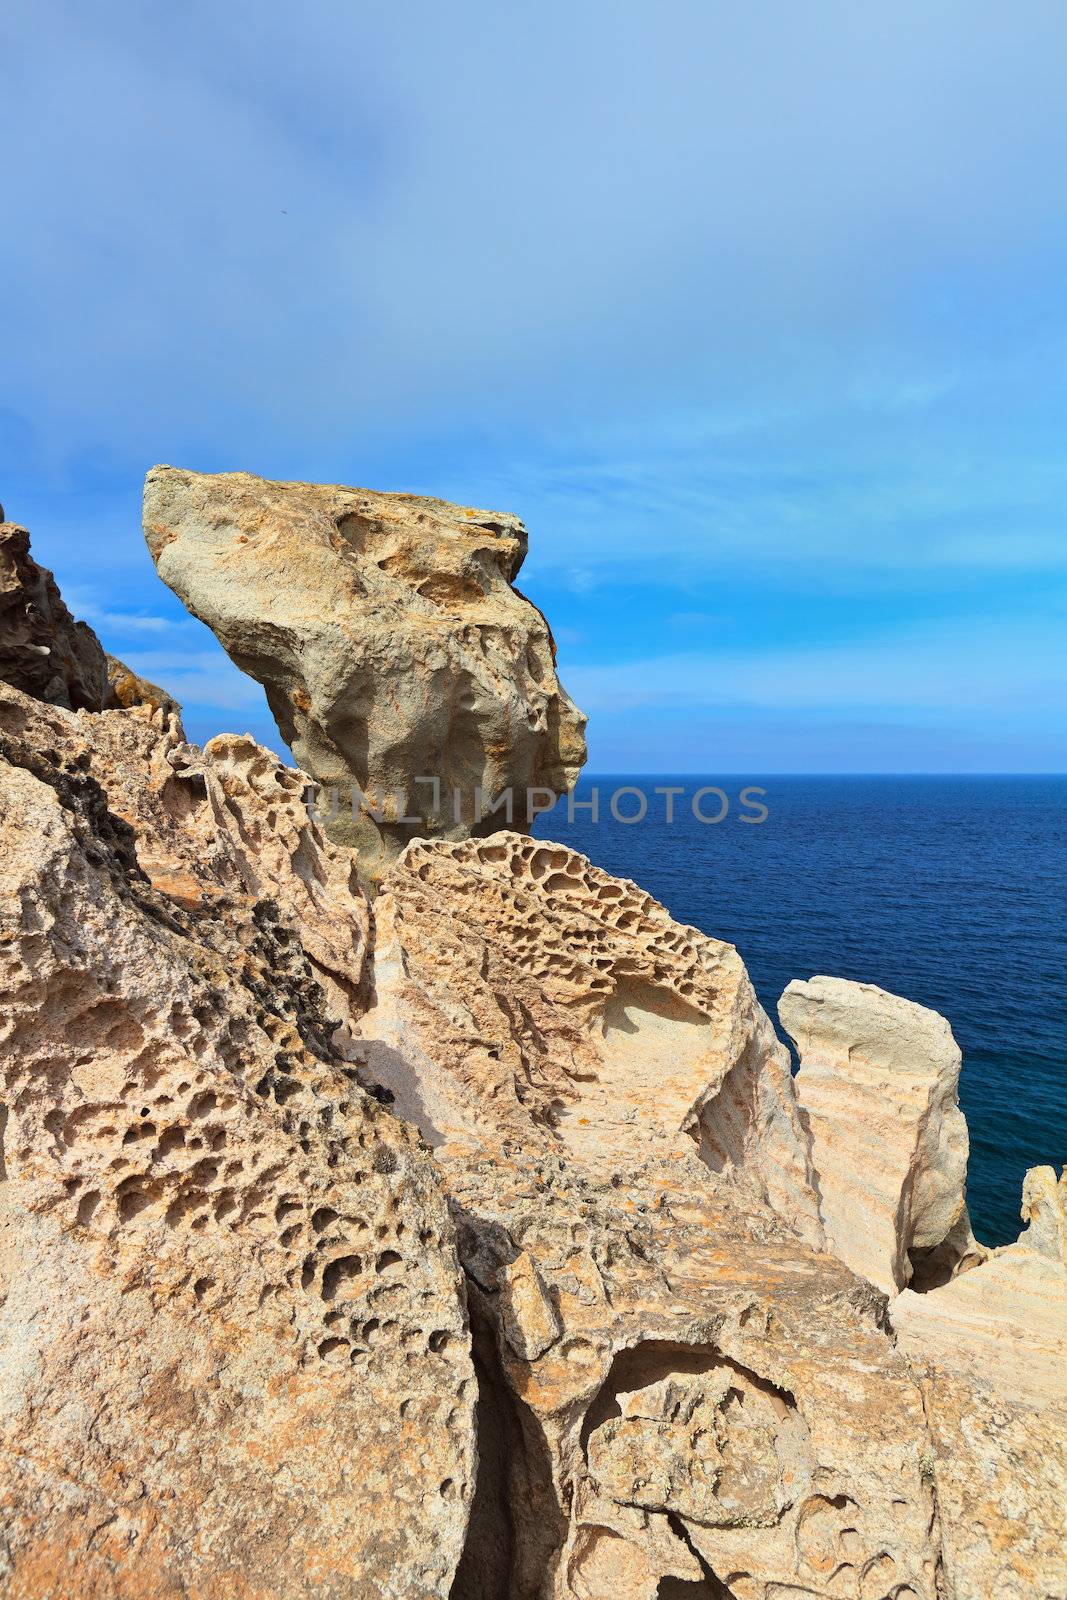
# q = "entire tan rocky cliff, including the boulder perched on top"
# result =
<box><xmin>0</xmin><ymin>483</ymin><xmax>1067</xmax><ymax>1600</ymax></box>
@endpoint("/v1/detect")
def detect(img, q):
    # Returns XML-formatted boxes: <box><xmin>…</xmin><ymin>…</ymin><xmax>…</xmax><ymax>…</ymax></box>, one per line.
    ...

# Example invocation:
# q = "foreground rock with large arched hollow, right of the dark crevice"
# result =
<box><xmin>438</xmin><ymin>1147</ymin><xmax>941</xmax><ymax>1600</ymax></box>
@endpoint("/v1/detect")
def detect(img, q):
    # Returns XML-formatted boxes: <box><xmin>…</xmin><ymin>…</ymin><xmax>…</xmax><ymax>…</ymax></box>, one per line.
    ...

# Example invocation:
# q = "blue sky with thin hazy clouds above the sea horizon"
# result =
<box><xmin>0</xmin><ymin>0</ymin><xmax>1067</xmax><ymax>774</ymax></box>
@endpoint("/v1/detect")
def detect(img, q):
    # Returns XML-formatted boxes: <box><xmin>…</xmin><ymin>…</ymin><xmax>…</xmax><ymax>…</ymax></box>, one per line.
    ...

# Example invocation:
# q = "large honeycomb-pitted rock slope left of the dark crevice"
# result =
<box><xmin>0</xmin><ymin>688</ymin><xmax>475</xmax><ymax>1600</ymax></box>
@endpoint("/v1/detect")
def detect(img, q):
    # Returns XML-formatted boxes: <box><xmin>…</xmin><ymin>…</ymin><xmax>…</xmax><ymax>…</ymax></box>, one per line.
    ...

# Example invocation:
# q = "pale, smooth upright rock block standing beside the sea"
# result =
<box><xmin>777</xmin><ymin>978</ymin><xmax>981</xmax><ymax>1294</ymax></box>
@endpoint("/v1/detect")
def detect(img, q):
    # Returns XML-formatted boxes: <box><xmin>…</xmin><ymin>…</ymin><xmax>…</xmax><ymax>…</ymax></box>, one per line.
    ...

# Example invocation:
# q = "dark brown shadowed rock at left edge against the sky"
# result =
<box><xmin>0</xmin><ymin>522</ymin><xmax>107</xmax><ymax>710</ymax></box>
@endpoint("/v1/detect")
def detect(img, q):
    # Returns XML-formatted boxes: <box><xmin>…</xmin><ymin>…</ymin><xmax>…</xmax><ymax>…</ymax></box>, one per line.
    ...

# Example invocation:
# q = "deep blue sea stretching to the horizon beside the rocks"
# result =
<box><xmin>536</xmin><ymin>776</ymin><xmax>1067</xmax><ymax>1245</ymax></box>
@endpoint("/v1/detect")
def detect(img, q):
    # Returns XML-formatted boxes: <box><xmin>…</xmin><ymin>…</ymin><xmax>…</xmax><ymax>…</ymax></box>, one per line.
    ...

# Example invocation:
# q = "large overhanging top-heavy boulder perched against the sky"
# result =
<box><xmin>144</xmin><ymin>467</ymin><xmax>585</xmax><ymax>875</ymax></box>
